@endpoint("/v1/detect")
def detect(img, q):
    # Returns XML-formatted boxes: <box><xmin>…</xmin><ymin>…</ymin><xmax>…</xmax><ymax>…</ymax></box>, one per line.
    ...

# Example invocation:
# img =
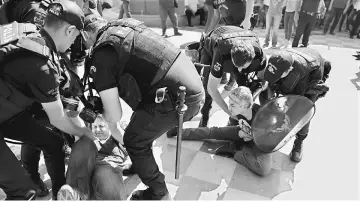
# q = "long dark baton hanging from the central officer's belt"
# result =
<box><xmin>175</xmin><ymin>86</ymin><xmax>187</xmax><ymax>179</ymax></box>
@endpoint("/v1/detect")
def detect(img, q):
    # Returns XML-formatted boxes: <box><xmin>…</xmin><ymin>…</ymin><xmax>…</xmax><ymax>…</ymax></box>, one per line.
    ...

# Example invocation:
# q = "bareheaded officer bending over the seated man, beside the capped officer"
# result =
<box><xmin>198</xmin><ymin>26</ymin><xmax>266</xmax><ymax>127</ymax></box>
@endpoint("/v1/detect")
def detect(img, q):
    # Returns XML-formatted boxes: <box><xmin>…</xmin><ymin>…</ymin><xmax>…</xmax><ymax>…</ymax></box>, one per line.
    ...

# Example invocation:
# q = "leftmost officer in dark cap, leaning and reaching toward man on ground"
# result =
<box><xmin>0</xmin><ymin>0</ymin><xmax>93</xmax><ymax>199</ymax></box>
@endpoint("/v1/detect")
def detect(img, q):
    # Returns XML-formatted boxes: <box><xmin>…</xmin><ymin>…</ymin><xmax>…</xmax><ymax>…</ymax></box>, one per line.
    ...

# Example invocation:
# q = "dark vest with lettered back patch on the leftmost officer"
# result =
<box><xmin>0</xmin><ymin>22</ymin><xmax>52</xmax><ymax>124</ymax></box>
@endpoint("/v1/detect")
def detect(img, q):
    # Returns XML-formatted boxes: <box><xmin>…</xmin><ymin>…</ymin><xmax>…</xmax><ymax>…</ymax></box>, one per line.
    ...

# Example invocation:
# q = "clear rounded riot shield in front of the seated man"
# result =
<box><xmin>252</xmin><ymin>95</ymin><xmax>315</xmax><ymax>153</ymax></box>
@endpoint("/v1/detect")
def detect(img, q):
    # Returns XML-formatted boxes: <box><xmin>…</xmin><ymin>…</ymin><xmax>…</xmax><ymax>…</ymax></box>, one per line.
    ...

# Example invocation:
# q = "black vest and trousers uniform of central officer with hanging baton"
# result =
<box><xmin>86</xmin><ymin>18</ymin><xmax>204</xmax><ymax>200</ymax></box>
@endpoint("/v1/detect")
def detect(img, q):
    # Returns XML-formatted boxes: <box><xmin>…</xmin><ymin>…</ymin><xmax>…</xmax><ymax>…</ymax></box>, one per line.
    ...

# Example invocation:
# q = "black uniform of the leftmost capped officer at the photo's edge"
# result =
<box><xmin>0</xmin><ymin>27</ymin><xmax>65</xmax><ymax>199</ymax></box>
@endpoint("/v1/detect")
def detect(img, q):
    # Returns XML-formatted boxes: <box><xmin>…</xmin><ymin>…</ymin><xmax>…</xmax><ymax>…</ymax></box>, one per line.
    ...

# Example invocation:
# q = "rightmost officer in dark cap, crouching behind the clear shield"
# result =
<box><xmin>262</xmin><ymin>48</ymin><xmax>331</xmax><ymax>162</ymax></box>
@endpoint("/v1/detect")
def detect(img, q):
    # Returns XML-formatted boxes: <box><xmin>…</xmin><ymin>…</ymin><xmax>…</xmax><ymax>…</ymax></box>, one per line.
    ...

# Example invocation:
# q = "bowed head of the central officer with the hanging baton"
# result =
<box><xmin>85</xmin><ymin>14</ymin><xmax>108</xmax><ymax>49</ymax></box>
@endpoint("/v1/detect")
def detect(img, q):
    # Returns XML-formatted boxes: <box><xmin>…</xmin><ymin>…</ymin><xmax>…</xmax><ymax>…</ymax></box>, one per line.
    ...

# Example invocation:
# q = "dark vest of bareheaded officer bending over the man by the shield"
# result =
<box><xmin>204</xmin><ymin>26</ymin><xmax>265</xmax><ymax>73</ymax></box>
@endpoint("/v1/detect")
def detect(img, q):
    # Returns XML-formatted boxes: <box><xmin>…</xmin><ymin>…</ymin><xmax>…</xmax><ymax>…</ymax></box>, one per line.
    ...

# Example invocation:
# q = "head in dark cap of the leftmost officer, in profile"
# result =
<box><xmin>44</xmin><ymin>0</ymin><xmax>85</xmax><ymax>52</ymax></box>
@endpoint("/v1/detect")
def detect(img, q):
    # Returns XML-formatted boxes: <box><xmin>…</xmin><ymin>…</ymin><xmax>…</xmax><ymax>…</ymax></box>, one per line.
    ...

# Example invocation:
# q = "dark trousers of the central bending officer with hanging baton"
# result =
<box><xmin>124</xmin><ymin>54</ymin><xmax>204</xmax><ymax>196</ymax></box>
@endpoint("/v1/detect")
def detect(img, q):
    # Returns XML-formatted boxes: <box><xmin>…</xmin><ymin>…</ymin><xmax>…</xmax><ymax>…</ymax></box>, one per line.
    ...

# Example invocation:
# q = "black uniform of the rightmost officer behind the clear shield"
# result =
<box><xmin>264</xmin><ymin>48</ymin><xmax>330</xmax><ymax>161</ymax></box>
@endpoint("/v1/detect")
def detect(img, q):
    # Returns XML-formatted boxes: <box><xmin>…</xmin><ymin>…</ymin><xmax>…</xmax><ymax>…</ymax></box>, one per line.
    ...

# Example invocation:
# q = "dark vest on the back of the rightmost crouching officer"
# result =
<box><xmin>280</xmin><ymin>48</ymin><xmax>324</xmax><ymax>95</ymax></box>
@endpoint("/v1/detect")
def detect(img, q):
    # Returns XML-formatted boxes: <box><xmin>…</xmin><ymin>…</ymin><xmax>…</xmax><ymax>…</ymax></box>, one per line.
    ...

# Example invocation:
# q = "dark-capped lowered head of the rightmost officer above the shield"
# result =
<box><xmin>264</xmin><ymin>51</ymin><xmax>294</xmax><ymax>84</ymax></box>
